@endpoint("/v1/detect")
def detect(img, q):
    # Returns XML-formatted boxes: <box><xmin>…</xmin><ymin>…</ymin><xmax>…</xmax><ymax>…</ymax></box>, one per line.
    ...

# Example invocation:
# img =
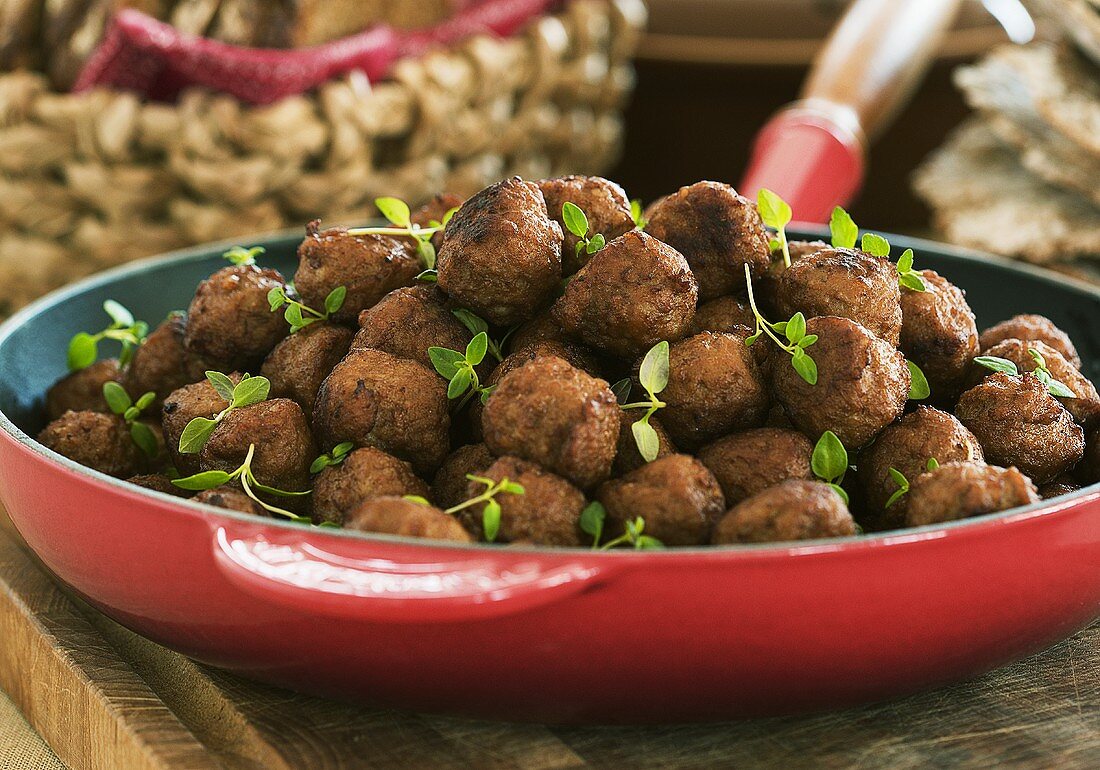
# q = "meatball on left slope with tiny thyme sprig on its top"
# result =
<box><xmin>184</xmin><ymin>265</ymin><xmax>289</xmax><ymax>372</ymax></box>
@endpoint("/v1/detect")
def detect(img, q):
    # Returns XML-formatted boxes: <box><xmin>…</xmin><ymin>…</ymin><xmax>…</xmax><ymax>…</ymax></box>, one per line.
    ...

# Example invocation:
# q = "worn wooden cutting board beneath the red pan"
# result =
<box><xmin>0</xmin><ymin>515</ymin><xmax>1100</xmax><ymax>770</ymax></box>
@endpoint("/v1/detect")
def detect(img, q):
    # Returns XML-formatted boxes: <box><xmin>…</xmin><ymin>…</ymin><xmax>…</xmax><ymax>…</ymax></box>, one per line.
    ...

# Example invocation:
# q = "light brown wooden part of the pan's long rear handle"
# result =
<box><xmin>802</xmin><ymin>0</ymin><xmax>960</xmax><ymax>139</ymax></box>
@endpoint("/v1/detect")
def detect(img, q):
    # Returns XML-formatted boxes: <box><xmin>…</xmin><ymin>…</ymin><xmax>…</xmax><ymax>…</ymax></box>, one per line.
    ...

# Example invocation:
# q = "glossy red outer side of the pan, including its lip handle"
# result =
<box><xmin>0</xmin><ymin>432</ymin><xmax>1100</xmax><ymax>723</ymax></box>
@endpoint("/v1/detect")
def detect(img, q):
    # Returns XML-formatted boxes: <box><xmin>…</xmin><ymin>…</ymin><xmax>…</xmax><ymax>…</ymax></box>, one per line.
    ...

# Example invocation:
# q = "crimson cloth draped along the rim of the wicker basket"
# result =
<box><xmin>73</xmin><ymin>0</ymin><xmax>558</xmax><ymax>105</ymax></box>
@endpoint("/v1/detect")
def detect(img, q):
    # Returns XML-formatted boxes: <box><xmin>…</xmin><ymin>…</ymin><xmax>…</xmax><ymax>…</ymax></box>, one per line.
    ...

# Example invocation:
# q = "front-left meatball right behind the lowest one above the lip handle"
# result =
<box><xmin>312</xmin><ymin>447</ymin><xmax>428</xmax><ymax>524</ymax></box>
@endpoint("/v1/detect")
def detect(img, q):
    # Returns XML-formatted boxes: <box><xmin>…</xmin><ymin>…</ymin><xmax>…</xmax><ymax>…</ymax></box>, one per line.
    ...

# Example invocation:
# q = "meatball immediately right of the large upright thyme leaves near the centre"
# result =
<box><xmin>658</xmin><ymin>331</ymin><xmax>771</xmax><ymax>449</ymax></box>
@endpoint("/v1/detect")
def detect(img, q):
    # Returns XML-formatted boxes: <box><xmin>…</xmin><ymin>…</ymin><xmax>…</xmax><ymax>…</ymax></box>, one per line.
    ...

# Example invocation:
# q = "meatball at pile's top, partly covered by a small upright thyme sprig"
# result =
<box><xmin>538</xmin><ymin>176</ymin><xmax>634</xmax><ymax>275</ymax></box>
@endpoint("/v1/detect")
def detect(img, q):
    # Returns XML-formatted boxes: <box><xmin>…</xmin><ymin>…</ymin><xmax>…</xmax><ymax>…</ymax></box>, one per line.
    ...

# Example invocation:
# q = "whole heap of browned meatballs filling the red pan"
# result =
<box><xmin>39</xmin><ymin>176</ymin><xmax>1100</xmax><ymax>547</ymax></box>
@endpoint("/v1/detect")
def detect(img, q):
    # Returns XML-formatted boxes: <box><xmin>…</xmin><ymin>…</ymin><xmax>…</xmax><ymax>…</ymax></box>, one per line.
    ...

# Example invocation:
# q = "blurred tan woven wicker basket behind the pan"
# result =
<box><xmin>0</xmin><ymin>0</ymin><xmax>646</xmax><ymax>312</ymax></box>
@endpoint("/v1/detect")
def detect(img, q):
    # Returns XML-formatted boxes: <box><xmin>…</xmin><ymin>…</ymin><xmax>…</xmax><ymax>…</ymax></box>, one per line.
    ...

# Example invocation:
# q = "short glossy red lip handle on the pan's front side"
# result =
<box><xmin>212</xmin><ymin>526</ymin><xmax>606</xmax><ymax>624</ymax></box>
